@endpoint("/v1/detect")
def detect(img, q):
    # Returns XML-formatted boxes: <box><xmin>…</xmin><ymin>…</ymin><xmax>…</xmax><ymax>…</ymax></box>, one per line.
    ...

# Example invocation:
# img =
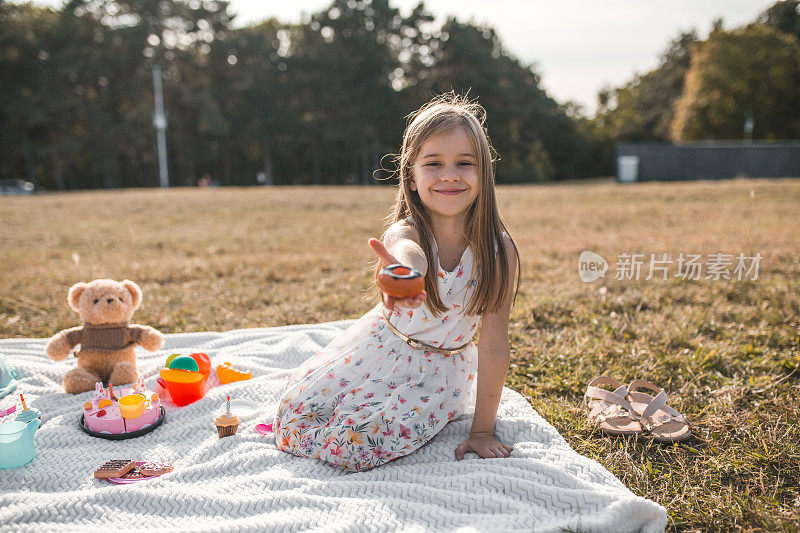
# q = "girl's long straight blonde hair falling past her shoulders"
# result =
<box><xmin>380</xmin><ymin>91</ymin><xmax>520</xmax><ymax>315</ymax></box>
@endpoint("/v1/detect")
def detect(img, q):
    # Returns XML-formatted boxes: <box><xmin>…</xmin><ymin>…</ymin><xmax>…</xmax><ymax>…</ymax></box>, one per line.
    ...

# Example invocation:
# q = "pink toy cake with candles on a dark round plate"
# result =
<box><xmin>83</xmin><ymin>380</ymin><xmax>161</xmax><ymax>435</ymax></box>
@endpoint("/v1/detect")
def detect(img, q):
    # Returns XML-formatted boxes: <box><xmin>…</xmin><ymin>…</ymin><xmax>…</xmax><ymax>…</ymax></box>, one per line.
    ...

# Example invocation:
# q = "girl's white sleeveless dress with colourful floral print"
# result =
<box><xmin>274</xmin><ymin>237</ymin><xmax>480</xmax><ymax>471</ymax></box>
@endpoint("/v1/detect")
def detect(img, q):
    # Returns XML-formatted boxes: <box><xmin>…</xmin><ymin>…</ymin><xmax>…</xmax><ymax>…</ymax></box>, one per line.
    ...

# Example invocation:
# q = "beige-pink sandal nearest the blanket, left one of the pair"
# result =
<box><xmin>583</xmin><ymin>376</ymin><xmax>643</xmax><ymax>436</ymax></box>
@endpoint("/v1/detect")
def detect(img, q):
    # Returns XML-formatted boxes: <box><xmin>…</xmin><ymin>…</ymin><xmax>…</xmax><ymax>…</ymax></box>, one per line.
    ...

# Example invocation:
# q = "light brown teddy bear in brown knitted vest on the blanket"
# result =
<box><xmin>45</xmin><ymin>279</ymin><xmax>164</xmax><ymax>394</ymax></box>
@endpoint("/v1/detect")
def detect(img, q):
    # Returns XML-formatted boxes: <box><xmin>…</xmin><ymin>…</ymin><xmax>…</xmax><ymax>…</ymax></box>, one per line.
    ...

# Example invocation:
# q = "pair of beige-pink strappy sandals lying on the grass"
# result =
<box><xmin>584</xmin><ymin>376</ymin><xmax>692</xmax><ymax>442</ymax></box>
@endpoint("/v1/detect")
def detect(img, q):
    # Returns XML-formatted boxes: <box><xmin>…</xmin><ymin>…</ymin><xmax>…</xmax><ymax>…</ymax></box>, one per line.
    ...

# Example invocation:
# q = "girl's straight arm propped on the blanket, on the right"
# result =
<box><xmin>455</xmin><ymin>235</ymin><xmax>517</xmax><ymax>461</ymax></box>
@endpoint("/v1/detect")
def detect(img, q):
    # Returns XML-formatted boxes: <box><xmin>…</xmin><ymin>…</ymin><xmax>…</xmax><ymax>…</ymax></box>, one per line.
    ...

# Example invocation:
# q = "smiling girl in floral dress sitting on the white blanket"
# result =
<box><xmin>274</xmin><ymin>93</ymin><xmax>519</xmax><ymax>471</ymax></box>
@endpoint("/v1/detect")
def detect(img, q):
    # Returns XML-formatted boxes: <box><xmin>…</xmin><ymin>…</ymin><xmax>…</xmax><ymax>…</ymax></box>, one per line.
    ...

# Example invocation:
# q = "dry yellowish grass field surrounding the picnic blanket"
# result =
<box><xmin>0</xmin><ymin>180</ymin><xmax>800</xmax><ymax>531</ymax></box>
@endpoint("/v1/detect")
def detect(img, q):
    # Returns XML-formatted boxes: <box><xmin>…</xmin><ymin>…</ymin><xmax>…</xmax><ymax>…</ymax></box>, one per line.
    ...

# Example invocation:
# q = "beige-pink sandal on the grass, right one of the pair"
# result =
<box><xmin>628</xmin><ymin>379</ymin><xmax>692</xmax><ymax>442</ymax></box>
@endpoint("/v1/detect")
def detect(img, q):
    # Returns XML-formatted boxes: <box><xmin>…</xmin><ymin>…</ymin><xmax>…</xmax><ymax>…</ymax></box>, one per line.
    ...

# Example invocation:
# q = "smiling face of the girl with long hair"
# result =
<box><xmin>409</xmin><ymin>127</ymin><xmax>480</xmax><ymax>217</ymax></box>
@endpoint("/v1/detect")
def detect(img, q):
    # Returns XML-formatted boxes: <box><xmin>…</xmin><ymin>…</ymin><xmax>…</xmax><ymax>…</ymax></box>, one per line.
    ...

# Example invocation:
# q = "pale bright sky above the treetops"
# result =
<box><xmin>21</xmin><ymin>0</ymin><xmax>774</xmax><ymax>116</ymax></box>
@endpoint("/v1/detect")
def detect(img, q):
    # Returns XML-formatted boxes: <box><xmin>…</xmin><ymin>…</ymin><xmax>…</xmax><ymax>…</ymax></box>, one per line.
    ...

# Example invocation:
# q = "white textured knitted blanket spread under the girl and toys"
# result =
<box><xmin>0</xmin><ymin>321</ymin><xmax>667</xmax><ymax>532</ymax></box>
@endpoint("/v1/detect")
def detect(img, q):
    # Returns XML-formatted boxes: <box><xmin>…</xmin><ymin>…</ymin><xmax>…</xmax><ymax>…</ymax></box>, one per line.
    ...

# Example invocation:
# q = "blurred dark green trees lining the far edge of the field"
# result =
<box><xmin>0</xmin><ymin>0</ymin><xmax>800</xmax><ymax>189</ymax></box>
